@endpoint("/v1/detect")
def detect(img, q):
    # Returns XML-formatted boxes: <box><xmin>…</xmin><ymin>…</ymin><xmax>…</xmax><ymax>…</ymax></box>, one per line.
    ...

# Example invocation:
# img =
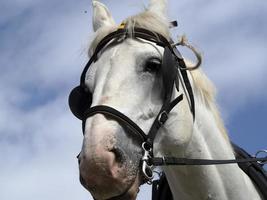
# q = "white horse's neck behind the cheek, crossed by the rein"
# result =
<box><xmin>160</xmin><ymin>84</ymin><xmax>261</xmax><ymax>200</ymax></box>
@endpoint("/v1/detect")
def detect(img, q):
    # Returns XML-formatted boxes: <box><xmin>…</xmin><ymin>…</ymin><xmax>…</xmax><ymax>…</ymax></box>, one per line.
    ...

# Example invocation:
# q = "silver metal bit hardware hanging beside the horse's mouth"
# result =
<box><xmin>142</xmin><ymin>142</ymin><xmax>154</xmax><ymax>184</ymax></box>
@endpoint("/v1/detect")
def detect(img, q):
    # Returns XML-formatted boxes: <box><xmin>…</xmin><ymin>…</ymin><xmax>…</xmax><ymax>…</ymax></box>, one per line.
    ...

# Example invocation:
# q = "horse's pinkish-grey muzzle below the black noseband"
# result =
<box><xmin>78</xmin><ymin>114</ymin><xmax>141</xmax><ymax>200</ymax></box>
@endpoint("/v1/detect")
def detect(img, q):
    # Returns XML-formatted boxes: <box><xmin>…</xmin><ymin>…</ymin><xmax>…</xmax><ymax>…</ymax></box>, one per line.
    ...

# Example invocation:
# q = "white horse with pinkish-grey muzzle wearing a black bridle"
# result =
<box><xmin>75</xmin><ymin>0</ymin><xmax>262</xmax><ymax>200</ymax></box>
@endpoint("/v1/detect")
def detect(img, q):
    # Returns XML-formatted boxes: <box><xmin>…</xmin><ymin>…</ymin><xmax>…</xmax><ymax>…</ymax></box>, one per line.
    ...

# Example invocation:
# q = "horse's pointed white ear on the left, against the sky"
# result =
<box><xmin>92</xmin><ymin>0</ymin><xmax>115</xmax><ymax>31</ymax></box>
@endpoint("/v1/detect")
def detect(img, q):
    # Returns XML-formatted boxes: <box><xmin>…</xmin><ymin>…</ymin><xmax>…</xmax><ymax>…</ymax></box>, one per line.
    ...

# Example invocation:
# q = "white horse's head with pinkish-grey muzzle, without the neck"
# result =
<box><xmin>69</xmin><ymin>0</ymin><xmax>192</xmax><ymax>199</ymax></box>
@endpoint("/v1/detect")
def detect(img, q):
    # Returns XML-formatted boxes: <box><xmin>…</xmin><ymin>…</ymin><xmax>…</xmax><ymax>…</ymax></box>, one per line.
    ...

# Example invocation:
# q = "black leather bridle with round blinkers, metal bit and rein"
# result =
<box><xmin>69</xmin><ymin>23</ymin><xmax>267</xmax><ymax>198</ymax></box>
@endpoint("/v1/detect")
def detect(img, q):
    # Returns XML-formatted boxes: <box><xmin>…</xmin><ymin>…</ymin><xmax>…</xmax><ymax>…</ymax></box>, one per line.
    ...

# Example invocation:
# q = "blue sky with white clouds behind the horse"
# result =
<box><xmin>0</xmin><ymin>0</ymin><xmax>267</xmax><ymax>200</ymax></box>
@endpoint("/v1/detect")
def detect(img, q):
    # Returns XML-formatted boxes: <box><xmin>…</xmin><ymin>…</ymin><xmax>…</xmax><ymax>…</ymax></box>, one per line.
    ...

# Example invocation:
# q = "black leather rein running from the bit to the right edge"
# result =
<box><xmin>150</xmin><ymin>157</ymin><xmax>267</xmax><ymax>166</ymax></box>
